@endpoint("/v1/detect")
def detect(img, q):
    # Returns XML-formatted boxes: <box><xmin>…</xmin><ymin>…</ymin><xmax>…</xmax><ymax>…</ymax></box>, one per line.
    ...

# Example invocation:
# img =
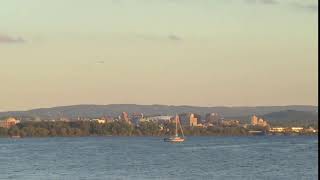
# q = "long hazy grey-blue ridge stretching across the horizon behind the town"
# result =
<box><xmin>0</xmin><ymin>104</ymin><xmax>318</xmax><ymax>119</ymax></box>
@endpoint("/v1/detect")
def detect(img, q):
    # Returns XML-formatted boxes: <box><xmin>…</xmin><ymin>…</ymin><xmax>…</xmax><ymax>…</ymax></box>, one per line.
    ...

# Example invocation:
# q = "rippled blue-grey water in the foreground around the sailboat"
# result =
<box><xmin>0</xmin><ymin>136</ymin><xmax>318</xmax><ymax>179</ymax></box>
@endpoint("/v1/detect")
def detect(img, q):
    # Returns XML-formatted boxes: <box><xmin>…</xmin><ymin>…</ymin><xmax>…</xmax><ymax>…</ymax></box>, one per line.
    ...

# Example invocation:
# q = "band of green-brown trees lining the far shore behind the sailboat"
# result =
<box><xmin>0</xmin><ymin>121</ymin><xmax>249</xmax><ymax>137</ymax></box>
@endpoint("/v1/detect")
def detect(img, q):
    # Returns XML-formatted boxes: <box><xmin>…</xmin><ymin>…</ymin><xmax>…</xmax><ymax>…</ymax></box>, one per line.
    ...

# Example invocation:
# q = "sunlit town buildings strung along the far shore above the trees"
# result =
<box><xmin>0</xmin><ymin>112</ymin><xmax>317</xmax><ymax>134</ymax></box>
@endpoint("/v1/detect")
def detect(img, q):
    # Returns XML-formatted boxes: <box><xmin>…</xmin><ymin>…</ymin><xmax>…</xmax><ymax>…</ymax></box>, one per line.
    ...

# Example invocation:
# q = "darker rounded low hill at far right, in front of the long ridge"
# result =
<box><xmin>263</xmin><ymin>110</ymin><xmax>318</xmax><ymax>127</ymax></box>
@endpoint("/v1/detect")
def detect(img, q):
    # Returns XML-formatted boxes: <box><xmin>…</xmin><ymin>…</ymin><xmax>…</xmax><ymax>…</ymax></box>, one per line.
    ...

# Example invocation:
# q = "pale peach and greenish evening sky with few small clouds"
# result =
<box><xmin>0</xmin><ymin>0</ymin><xmax>318</xmax><ymax>111</ymax></box>
